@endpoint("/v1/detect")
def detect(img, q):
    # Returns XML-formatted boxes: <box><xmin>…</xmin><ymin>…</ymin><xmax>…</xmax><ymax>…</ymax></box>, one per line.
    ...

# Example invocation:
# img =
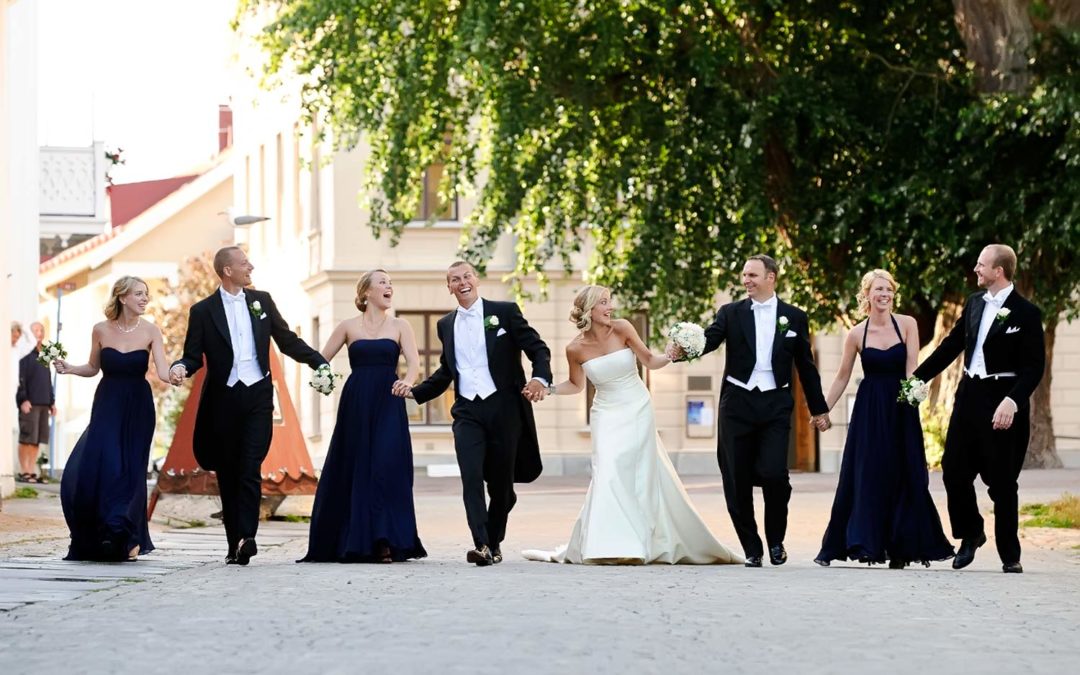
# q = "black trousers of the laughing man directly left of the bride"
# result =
<box><xmin>450</xmin><ymin>392</ymin><xmax>522</xmax><ymax>549</ymax></box>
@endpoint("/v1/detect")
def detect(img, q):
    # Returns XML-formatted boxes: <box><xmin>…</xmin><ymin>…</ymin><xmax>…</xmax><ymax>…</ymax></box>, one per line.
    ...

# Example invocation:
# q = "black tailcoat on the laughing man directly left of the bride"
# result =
<box><xmin>413</xmin><ymin>298</ymin><xmax>552</xmax><ymax>483</ymax></box>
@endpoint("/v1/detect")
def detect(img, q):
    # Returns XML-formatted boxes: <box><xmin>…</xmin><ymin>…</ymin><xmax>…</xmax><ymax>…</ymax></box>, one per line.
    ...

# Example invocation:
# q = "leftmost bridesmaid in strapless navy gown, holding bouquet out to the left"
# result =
<box><xmin>53</xmin><ymin>276</ymin><xmax>168</xmax><ymax>561</ymax></box>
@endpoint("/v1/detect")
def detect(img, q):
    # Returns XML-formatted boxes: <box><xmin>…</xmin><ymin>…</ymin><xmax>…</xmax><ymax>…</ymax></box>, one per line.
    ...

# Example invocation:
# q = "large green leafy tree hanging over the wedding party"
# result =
<box><xmin>240</xmin><ymin>0</ymin><xmax>1080</xmax><ymax>466</ymax></box>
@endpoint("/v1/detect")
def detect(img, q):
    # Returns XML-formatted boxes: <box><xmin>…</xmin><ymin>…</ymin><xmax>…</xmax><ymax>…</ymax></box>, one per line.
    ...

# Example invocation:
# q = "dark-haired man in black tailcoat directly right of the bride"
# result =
<box><xmin>670</xmin><ymin>255</ymin><xmax>832</xmax><ymax>567</ymax></box>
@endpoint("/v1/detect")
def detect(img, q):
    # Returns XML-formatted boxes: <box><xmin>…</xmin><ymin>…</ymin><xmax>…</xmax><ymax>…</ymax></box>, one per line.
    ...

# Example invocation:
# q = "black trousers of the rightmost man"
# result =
<box><xmin>942</xmin><ymin>376</ymin><xmax>1031</xmax><ymax>563</ymax></box>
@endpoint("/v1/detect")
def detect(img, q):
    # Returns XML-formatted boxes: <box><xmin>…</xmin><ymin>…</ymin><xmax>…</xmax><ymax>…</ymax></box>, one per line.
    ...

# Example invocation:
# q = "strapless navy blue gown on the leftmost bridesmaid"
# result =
<box><xmin>60</xmin><ymin>347</ymin><xmax>154</xmax><ymax>561</ymax></box>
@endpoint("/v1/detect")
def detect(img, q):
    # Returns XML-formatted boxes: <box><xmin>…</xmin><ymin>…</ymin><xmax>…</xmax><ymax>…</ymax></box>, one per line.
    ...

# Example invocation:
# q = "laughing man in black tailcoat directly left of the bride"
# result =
<box><xmin>407</xmin><ymin>261</ymin><xmax>551</xmax><ymax>566</ymax></box>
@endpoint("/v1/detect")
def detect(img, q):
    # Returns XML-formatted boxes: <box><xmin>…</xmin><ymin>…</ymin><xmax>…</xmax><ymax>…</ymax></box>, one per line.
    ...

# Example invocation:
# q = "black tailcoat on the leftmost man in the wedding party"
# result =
<box><xmin>173</xmin><ymin>288</ymin><xmax>326</xmax><ymax>471</ymax></box>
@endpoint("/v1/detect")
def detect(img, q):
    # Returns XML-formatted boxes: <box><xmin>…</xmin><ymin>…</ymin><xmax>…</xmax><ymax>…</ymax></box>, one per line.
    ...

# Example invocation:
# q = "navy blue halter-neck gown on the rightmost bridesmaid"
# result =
<box><xmin>815</xmin><ymin>316</ymin><xmax>954</xmax><ymax>566</ymax></box>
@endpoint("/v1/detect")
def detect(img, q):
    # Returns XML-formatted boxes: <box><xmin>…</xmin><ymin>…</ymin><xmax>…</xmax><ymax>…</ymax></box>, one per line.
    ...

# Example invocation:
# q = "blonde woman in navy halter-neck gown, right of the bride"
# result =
<box><xmin>814</xmin><ymin>270</ymin><xmax>953</xmax><ymax>569</ymax></box>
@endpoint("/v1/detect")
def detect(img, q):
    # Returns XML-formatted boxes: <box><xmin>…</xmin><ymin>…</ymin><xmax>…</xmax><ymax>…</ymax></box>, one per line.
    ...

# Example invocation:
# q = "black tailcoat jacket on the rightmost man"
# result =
<box><xmin>914</xmin><ymin>288</ymin><xmax>1047</xmax><ymax>408</ymax></box>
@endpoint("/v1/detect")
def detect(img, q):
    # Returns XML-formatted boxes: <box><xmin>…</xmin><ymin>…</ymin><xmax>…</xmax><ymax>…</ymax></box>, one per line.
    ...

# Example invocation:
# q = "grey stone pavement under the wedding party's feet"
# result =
<box><xmin>0</xmin><ymin>471</ymin><xmax>1080</xmax><ymax>675</ymax></box>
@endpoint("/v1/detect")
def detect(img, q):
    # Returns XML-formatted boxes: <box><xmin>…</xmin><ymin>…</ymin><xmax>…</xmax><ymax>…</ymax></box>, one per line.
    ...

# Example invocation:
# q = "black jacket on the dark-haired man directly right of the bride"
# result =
<box><xmin>702</xmin><ymin>297</ymin><xmax>828</xmax><ymax>415</ymax></box>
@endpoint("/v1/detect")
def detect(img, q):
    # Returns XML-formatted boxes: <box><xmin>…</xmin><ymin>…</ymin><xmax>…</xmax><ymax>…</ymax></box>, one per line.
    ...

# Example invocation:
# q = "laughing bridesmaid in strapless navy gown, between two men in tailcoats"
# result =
<box><xmin>299</xmin><ymin>270</ymin><xmax>428</xmax><ymax>563</ymax></box>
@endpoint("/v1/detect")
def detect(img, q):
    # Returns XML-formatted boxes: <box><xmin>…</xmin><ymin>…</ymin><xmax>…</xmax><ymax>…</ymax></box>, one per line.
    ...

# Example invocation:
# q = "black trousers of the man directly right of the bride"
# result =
<box><xmin>717</xmin><ymin>383</ymin><xmax>795</xmax><ymax>556</ymax></box>
